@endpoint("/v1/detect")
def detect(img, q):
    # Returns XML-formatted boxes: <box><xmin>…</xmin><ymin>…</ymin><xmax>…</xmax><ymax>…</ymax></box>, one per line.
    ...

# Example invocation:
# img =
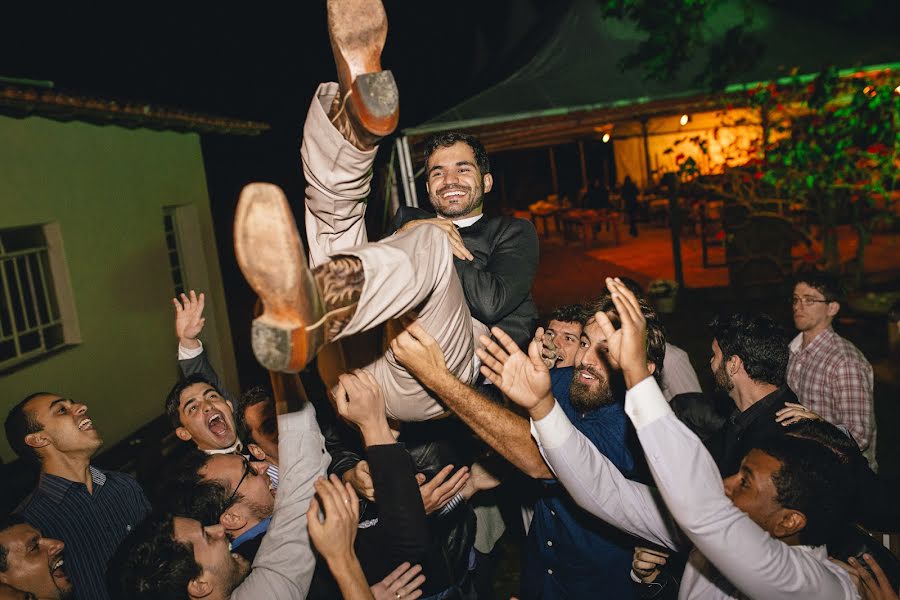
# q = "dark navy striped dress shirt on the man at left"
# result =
<box><xmin>16</xmin><ymin>466</ymin><xmax>150</xmax><ymax>600</ymax></box>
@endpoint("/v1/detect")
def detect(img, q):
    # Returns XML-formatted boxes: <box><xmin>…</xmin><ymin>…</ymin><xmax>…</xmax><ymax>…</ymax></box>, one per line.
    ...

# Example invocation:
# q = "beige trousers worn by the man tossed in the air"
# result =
<box><xmin>300</xmin><ymin>83</ymin><xmax>488</xmax><ymax>421</ymax></box>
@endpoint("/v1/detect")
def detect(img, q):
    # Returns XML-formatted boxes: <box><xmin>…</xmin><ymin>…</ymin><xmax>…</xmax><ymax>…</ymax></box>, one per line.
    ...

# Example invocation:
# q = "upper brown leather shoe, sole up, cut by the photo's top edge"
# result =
<box><xmin>328</xmin><ymin>0</ymin><xmax>400</xmax><ymax>149</ymax></box>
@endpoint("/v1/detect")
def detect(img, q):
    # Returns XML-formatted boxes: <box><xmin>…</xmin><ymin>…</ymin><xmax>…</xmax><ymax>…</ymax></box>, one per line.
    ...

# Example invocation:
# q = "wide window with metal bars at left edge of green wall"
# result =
<box><xmin>0</xmin><ymin>225</ymin><xmax>68</xmax><ymax>371</ymax></box>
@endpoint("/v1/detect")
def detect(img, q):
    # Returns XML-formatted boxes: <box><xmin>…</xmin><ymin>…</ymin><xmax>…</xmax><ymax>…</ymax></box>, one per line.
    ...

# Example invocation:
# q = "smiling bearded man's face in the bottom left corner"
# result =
<box><xmin>0</xmin><ymin>523</ymin><xmax>72</xmax><ymax>600</ymax></box>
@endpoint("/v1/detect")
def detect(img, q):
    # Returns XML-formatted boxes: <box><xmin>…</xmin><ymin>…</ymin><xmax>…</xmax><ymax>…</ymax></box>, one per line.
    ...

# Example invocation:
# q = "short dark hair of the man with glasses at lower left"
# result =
<box><xmin>160</xmin><ymin>450</ymin><xmax>242</xmax><ymax>525</ymax></box>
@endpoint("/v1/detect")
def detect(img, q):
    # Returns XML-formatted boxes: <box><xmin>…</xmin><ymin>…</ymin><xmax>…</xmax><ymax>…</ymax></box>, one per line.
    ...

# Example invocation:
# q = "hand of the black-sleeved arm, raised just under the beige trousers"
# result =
<box><xmin>334</xmin><ymin>369</ymin><xmax>394</xmax><ymax>446</ymax></box>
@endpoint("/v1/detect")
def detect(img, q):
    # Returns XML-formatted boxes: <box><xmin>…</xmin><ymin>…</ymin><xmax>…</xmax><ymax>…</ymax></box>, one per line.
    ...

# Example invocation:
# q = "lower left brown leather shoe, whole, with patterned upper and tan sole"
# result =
<box><xmin>234</xmin><ymin>183</ymin><xmax>365</xmax><ymax>373</ymax></box>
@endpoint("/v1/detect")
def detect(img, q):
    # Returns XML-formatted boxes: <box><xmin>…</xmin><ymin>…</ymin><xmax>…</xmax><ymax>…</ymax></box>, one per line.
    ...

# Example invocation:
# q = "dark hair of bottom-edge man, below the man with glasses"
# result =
<box><xmin>107</xmin><ymin>513</ymin><xmax>203</xmax><ymax>600</ymax></box>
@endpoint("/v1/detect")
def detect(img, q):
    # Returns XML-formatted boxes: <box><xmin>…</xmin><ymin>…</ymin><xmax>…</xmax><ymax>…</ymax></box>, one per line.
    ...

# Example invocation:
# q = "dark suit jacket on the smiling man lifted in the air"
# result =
<box><xmin>393</xmin><ymin>206</ymin><xmax>540</xmax><ymax>348</ymax></box>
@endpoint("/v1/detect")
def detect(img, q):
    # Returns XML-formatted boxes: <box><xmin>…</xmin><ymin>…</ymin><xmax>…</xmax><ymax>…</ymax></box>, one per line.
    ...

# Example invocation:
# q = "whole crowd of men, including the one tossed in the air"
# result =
<box><xmin>0</xmin><ymin>0</ymin><xmax>900</xmax><ymax>600</ymax></box>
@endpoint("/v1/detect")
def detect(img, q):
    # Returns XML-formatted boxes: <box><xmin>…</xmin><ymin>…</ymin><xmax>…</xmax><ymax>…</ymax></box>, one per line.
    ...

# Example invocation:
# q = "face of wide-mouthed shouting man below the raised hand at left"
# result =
<box><xmin>175</xmin><ymin>383</ymin><xmax>237</xmax><ymax>450</ymax></box>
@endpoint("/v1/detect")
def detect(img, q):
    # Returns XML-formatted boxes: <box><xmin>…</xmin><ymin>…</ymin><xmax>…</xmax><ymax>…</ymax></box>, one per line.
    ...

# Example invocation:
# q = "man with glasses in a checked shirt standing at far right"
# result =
<box><xmin>787</xmin><ymin>272</ymin><xmax>877</xmax><ymax>470</ymax></box>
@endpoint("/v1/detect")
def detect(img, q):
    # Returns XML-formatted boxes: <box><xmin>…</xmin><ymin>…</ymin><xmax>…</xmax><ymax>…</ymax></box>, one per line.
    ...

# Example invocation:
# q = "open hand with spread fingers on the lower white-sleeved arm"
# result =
<box><xmin>476</xmin><ymin>327</ymin><xmax>554</xmax><ymax>418</ymax></box>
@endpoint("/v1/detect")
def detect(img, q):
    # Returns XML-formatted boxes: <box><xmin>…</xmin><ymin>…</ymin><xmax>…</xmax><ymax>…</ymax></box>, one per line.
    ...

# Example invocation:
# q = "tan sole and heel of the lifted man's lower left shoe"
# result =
<box><xmin>234</xmin><ymin>183</ymin><xmax>324</xmax><ymax>373</ymax></box>
